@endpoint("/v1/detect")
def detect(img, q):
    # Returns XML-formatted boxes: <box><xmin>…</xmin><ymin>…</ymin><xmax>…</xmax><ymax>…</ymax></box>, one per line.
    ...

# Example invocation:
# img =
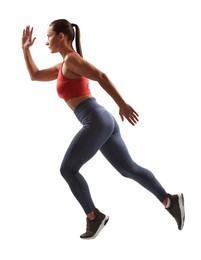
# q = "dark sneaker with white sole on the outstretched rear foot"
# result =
<box><xmin>167</xmin><ymin>193</ymin><xmax>185</xmax><ymax>230</ymax></box>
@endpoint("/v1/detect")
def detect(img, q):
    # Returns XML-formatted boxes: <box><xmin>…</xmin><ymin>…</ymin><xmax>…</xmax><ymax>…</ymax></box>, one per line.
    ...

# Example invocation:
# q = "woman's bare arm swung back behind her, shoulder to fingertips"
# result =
<box><xmin>66</xmin><ymin>54</ymin><xmax>138</xmax><ymax>125</ymax></box>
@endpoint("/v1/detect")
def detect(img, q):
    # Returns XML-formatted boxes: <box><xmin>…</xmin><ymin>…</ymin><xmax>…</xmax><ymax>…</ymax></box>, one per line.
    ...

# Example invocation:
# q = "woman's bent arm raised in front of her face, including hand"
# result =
<box><xmin>22</xmin><ymin>26</ymin><xmax>60</xmax><ymax>81</ymax></box>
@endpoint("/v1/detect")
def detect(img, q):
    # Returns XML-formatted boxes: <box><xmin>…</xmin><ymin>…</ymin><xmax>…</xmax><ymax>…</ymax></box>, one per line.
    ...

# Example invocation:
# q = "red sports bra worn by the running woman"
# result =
<box><xmin>57</xmin><ymin>63</ymin><xmax>91</xmax><ymax>101</ymax></box>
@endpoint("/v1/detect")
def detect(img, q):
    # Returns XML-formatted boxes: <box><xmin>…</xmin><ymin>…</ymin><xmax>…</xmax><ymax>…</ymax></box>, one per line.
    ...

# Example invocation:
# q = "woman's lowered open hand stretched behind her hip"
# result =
<box><xmin>119</xmin><ymin>104</ymin><xmax>139</xmax><ymax>125</ymax></box>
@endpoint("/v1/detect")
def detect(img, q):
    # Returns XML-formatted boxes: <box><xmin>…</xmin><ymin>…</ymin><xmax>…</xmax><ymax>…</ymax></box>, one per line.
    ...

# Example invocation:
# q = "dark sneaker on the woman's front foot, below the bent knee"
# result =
<box><xmin>80</xmin><ymin>209</ymin><xmax>109</xmax><ymax>239</ymax></box>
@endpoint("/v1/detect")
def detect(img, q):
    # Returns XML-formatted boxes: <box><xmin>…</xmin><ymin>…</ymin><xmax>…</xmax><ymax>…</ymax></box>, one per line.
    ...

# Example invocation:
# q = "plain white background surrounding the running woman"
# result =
<box><xmin>0</xmin><ymin>0</ymin><xmax>201</xmax><ymax>260</ymax></box>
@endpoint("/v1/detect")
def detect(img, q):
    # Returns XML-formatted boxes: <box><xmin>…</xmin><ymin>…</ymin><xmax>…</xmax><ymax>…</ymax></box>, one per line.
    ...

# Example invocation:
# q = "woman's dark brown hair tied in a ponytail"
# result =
<box><xmin>49</xmin><ymin>19</ymin><xmax>83</xmax><ymax>57</ymax></box>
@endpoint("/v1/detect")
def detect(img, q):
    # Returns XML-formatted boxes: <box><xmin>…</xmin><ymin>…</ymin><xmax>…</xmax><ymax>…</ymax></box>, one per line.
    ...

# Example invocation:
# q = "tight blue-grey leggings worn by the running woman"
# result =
<box><xmin>60</xmin><ymin>98</ymin><xmax>167</xmax><ymax>214</ymax></box>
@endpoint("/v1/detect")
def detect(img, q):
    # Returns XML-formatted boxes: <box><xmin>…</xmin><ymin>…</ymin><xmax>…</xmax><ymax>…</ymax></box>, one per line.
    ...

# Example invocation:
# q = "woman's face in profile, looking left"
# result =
<box><xmin>46</xmin><ymin>26</ymin><xmax>61</xmax><ymax>53</ymax></box>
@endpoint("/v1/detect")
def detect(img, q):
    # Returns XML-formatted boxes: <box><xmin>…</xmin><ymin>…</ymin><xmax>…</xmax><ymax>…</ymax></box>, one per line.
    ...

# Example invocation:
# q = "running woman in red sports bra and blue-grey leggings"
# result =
<box><xmin>22</xmin><ymin>19</ymin><xmax>185</xmax><ymax>239</ymax></box>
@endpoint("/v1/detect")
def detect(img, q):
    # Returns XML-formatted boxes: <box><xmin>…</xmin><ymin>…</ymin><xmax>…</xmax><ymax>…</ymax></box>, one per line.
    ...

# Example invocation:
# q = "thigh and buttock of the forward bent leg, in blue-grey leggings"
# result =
<box><xmin>62</xmin><ymin>109</ymin><xmax>114</xmax><ymax>171</ymax></box>
